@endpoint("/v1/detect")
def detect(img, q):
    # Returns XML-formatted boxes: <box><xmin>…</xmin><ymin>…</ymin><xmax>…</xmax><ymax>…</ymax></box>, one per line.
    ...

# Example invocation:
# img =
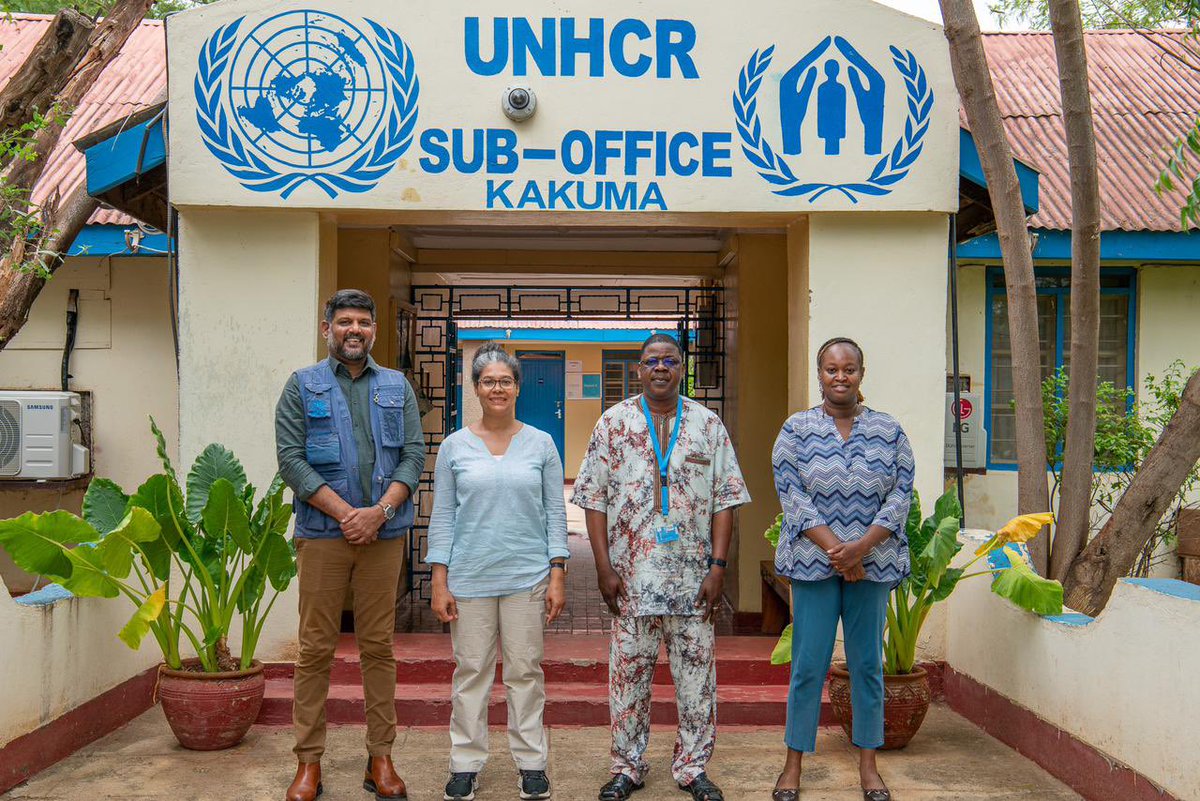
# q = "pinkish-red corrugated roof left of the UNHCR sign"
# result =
<box><xmin>0</xmin><ymin>13</ymin><xmax>167</xmax><ymax>225</ymax></box>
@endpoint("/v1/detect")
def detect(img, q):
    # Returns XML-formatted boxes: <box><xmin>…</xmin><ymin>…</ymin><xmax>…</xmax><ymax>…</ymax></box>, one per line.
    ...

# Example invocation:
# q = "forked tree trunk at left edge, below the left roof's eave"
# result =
<box><xmin>0</xmin><ymin>185</ymin><xmax>100</xmax><ymax>350</ymax></box>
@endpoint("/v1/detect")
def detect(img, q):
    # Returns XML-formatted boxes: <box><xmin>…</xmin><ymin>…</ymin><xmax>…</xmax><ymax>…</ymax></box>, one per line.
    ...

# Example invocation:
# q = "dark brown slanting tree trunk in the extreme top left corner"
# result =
<box><xmin>0</xmin><ymin>8</ymin><xmax>96</xmax><ymax>172</ymax></box>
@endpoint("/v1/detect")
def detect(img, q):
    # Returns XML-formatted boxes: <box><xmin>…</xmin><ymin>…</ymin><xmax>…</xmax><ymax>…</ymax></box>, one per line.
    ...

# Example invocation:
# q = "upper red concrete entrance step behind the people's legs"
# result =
<box><xmin>266</xmin><ymin>634</ymin><xmax>790</xmax><ymax>686</ymax></box>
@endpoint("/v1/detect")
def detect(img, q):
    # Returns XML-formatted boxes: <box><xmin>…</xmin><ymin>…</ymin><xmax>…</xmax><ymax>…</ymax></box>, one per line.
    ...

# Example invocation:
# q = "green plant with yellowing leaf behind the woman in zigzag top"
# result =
<box><xmin>763</xmin><ymin>487</ymin><xmax>1062</xmax><ymax>675</ymax></box>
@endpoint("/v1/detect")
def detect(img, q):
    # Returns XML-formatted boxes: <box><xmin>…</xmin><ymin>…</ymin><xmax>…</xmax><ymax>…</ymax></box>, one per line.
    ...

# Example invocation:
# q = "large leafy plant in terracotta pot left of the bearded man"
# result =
<box><xmin>0</xmin><ymin>418</ymin><xmax>295</xmax><ymax>751</ymax></box>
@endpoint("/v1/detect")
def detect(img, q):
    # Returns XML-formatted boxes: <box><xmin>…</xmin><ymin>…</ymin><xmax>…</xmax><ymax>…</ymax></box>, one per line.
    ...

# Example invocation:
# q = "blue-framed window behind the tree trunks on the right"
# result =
<box><xmin>986</xmin><ymin>267</ymin><xmax>1136</xmax><ymax>468</ymax></box>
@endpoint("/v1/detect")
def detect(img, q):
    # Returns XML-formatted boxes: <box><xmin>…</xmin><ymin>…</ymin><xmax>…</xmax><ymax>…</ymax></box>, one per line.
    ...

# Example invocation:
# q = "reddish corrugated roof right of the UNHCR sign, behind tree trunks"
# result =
<box><xmin>984</xmin><ymin>30</ymin><xmax>1200</xmax><ymax>230</ymax></box>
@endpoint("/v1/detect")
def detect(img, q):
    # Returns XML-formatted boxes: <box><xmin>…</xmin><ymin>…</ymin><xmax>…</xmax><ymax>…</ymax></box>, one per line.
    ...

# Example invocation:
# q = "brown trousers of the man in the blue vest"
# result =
<box><xmin>292</xmin><ymin>537</ymin><xmax>404</xmax><ymax>763</ymax></box>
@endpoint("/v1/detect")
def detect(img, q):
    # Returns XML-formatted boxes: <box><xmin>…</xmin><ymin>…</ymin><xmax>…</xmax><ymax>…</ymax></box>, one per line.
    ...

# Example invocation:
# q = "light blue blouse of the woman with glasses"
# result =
<box><xmin>425</xmin><ymin>424</ymin><xmax>571</xmax><ymax>598</ymax></box>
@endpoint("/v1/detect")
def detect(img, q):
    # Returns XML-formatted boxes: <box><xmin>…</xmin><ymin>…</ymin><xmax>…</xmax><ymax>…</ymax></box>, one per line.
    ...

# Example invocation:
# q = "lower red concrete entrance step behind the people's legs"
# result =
<box><xmin>258</xmin><ymin>679</ymin><xmax>836</xmax><ymax>727</ymax></box>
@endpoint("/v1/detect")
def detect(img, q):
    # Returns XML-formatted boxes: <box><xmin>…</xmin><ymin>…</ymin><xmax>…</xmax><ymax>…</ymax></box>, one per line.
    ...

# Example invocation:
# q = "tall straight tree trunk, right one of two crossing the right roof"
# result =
<box><xmin>1050</xmin><ymin>0</ymin><xmax>1100</xmax><ymax>580</ymax></box>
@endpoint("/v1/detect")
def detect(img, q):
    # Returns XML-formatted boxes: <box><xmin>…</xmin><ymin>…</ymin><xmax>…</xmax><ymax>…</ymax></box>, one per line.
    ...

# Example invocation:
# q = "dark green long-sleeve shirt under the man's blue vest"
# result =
<box><xmin>275</xmin><ymin>356</ymin><xmax>425</xmax><ymax>500</ymax></box>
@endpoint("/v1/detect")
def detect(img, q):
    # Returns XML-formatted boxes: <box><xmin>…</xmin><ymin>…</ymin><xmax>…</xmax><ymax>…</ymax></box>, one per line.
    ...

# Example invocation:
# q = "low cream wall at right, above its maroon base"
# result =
<box><xmin>947</xmin><ymin>579</ymin><xmax>1200</xmax><ymax>799</ymax></box>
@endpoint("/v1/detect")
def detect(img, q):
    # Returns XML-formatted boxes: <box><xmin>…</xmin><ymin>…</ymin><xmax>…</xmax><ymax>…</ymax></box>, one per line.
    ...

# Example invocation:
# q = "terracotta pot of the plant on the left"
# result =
<box><xmin>158</xmin><ymin>660</ymin><xmax>266</xmax><ymax>751</ymax></box>
